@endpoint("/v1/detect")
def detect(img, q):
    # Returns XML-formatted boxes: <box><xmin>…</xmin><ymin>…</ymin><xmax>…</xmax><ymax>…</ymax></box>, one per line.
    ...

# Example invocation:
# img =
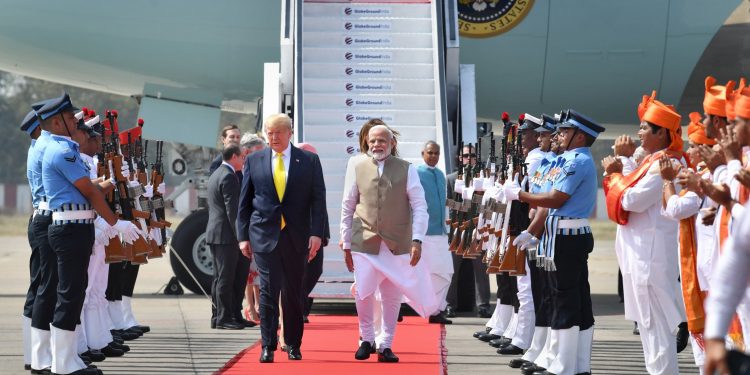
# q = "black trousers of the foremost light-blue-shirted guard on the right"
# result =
<box><xmin>548</xmin><ymin>233</ymin><xmax>594</xmax><ymax>331</ymax></box>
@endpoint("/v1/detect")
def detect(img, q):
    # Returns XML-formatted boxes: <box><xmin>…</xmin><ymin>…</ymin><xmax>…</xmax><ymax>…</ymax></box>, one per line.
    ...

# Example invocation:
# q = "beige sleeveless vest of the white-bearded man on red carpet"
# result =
<box><xmin>352</xmin><ymin>156</ymin><xmax>412</xmax><ymax>255</ymax></box>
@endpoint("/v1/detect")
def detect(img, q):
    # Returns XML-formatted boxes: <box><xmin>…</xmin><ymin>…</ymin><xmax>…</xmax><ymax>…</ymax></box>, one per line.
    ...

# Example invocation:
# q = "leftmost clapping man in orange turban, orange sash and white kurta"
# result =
<box><xmin>602</xmin><ymin>94</ymin><xmax>684</xmax><ymax>374</ymax></box>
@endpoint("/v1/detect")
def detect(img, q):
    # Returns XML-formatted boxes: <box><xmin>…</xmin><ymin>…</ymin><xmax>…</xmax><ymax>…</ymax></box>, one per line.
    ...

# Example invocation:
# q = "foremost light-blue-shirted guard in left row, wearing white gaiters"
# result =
<box><xmin>38</xmin><ymin>94</ymin><xmax>138</xmax><ymax>375</ymax></box>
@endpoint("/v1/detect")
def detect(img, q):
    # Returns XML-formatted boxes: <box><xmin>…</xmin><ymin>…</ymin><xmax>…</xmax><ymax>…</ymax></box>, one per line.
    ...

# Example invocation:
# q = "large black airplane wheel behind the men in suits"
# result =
<box><xmin>169</xmin><ymin>209</ymin><xmax>214</xmax><ymax>295</ymax></box>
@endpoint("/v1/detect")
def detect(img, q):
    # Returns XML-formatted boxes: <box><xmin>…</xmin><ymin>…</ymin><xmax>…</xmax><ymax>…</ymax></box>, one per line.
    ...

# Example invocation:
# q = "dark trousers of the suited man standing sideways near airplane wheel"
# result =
<box><xmin>209</xmin><ymin>243</ymin><xmax>250</xmax><ymax>324</ymax></box>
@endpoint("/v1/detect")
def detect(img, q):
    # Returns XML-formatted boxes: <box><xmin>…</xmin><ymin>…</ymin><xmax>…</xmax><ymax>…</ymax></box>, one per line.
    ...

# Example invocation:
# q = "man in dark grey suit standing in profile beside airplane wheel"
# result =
<box><xmin>206</xmin><ymin>145</ymin><xmax>250</xmax><ymax>329</ymax></box>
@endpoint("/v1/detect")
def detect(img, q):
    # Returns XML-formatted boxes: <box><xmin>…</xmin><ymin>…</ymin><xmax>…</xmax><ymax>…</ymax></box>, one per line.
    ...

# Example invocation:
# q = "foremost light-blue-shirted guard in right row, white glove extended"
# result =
<box><xmin>504</xmin><ymin>110</ymin><xmax>604</xmax><ymax>375</ymax></box>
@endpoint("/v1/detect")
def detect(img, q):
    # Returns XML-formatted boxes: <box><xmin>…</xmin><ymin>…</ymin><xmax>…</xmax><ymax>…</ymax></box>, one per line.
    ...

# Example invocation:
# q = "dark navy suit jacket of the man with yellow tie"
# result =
<box><xmin>237</xmin><ymin>146</ymin><xmax>326</xmax><ymax>253</ymax></box>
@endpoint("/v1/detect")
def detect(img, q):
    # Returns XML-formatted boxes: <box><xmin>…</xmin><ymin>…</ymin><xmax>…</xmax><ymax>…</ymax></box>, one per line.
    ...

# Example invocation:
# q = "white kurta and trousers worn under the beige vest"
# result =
<box><xmin>341</xmin><ymin>158</ymin><xmax>438</xmax><ymax>350</ymax></box>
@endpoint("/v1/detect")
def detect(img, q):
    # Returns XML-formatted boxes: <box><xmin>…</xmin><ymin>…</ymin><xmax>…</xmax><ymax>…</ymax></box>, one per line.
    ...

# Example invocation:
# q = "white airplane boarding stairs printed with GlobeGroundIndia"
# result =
<box><xmin>272</xmin><ymin>0</ymin><xmax>451</xmax><ymax>298</ymax></box>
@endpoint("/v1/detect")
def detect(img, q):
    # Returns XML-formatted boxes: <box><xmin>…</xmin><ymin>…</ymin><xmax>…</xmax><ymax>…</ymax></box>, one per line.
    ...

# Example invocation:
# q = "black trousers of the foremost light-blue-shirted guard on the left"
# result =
<box><xmin>48</xmin><ymin>224</ymin><xmax>94</xmax><ymax>331</ymax></box>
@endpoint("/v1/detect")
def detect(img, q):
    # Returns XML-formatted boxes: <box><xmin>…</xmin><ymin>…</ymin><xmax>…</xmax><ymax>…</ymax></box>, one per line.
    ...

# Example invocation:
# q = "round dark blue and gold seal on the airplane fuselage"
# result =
<box><xmin>458</xmin><ymin>0</ymin><xmax>534</xmax><ymax>38</ymax></box>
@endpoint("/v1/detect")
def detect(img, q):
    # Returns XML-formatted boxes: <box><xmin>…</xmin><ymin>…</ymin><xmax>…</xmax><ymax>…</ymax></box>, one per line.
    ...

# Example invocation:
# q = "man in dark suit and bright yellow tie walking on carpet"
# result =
<box><xmin>237</xmin><ymin>114</ymin><xmax>326</xmax><ymax>362</ymax></box>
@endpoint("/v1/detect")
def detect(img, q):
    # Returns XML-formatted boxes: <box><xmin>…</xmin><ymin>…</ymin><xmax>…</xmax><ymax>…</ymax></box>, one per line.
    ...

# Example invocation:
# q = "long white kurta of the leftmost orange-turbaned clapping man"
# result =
<box><xmin>615</xmin><ymin>160</ymin><xmax>684</xmax><ymax>374</ymax></box>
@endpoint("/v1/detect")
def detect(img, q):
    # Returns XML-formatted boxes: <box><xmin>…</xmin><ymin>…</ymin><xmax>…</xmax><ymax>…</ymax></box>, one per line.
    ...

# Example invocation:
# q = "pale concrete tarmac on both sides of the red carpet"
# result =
<box><xmin>0</xmin><ymin>236</ymin><xmax>698</xmax><ymax>375</ymax></box>
